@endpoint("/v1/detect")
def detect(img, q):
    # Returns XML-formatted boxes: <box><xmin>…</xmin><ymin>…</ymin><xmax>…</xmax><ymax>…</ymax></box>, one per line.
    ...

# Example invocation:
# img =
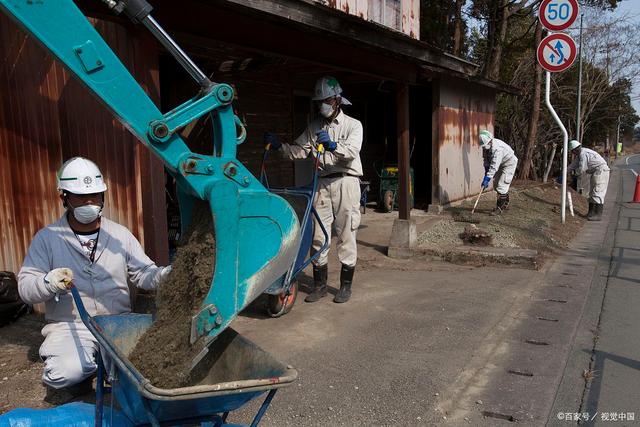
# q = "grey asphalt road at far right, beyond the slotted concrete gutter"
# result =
<box><xmin>548</xmin><ymin>155</ymin><xmax>640</xmax><ymax>426</ymax></box>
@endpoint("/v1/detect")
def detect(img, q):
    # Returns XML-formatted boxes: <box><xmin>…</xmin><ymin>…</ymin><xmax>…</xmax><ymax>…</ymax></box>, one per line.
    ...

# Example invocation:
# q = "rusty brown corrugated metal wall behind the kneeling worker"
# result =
<box><xmin>0</xmin><ymin>14</ymin><xmax>164</xmax><ymax>271</ymax></box>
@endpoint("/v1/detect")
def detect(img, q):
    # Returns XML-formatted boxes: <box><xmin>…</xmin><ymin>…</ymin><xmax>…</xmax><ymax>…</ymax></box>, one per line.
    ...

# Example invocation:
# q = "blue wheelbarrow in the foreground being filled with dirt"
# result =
<box><xmin>56</xmin><ymin>288</ymin><xmax>298</xmax><ymax>427</ymax></box>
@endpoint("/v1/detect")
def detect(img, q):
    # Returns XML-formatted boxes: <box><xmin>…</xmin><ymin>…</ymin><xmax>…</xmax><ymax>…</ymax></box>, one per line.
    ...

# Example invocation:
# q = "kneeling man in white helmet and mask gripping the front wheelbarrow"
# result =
<box><xmin>18</xmin><ymin>157</ymin><xmax>171</xmax><ymax>398</ymax></box>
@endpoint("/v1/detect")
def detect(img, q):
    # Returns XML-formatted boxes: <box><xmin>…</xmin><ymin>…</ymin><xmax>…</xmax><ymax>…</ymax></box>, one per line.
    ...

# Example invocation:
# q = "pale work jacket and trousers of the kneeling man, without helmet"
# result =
<box><xmin>18</xmin><ymin>213</ymin><xmax>165</xmax><ymax>388</ymax></box>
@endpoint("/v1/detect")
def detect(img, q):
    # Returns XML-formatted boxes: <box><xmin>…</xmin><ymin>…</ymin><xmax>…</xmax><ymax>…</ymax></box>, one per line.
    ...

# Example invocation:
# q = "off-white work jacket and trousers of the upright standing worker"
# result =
<box><xmin>282</xmin><ymin>110</ymin><xmax>363</xmax><ymax>267</ymax></box>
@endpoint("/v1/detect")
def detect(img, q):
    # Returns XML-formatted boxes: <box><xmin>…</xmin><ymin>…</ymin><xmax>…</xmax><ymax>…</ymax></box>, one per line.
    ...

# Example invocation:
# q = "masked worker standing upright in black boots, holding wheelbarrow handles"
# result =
<box><xmin>265</xmin><ymin>77</ymin><xmax>363</xmax><ymax>303</ymax></box>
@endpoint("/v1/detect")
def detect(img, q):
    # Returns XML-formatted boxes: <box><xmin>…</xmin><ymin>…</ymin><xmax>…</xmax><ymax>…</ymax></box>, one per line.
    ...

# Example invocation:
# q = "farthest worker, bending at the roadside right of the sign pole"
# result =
<box><xmin>567</xmin><ymin>139</ymin><xmax>611</xmax><ymax>221</ymax></box>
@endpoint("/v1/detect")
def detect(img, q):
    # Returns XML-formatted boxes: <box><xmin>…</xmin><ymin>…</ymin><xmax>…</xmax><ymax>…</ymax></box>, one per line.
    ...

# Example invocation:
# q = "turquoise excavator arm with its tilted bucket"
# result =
<box><xmin>0</xmin><ymin>0</ymin><xmax>300</xmax><ymax>344</ymax></box>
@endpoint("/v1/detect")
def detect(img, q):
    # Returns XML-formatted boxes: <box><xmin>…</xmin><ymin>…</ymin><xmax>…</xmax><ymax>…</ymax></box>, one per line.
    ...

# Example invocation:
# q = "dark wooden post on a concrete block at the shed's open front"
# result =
<box><xmin>397</xmin><ymin>83</ymin><xmax>411</xmax><ymax>220</ymax></box>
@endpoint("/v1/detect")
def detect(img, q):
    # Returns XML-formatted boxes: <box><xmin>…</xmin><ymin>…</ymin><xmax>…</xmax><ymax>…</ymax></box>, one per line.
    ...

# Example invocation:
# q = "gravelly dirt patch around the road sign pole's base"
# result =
<box><xmin>418</xmin><ymin>181</ymin><xmax>588</xmax><ymax>254</ymax></box>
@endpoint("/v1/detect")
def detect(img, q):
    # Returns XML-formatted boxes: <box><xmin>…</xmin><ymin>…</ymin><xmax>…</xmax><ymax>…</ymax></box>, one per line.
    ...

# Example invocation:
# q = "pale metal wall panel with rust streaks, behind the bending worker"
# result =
<box><xmin>432</xmin><ymin>78</ymin><xmax>495</xmax><ymax>204</ymax></box>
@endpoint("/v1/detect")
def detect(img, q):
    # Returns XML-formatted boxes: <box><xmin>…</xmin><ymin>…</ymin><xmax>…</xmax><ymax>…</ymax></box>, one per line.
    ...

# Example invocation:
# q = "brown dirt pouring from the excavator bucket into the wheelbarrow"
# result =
<box><xmin>129</xmin><ymin>203</ymin><xmax>215</xmax><ymax>388</ymax></box>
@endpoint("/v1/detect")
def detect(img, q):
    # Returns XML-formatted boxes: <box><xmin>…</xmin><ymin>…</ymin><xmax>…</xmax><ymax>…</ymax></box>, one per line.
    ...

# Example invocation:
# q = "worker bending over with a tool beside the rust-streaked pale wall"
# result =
<box><xmin>480</xmin><ymin>130</ymin><xmax>518</xmax><ymax>215</ymax></box>
